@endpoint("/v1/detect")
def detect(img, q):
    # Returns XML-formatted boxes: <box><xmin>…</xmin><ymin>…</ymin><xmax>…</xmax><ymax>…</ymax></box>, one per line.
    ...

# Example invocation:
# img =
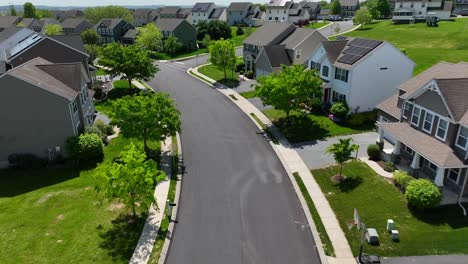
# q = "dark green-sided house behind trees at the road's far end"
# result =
<box><xmin>154</xmin><ymin>18</ymin><xmax>197</xmax><ymax>50</ymax></box>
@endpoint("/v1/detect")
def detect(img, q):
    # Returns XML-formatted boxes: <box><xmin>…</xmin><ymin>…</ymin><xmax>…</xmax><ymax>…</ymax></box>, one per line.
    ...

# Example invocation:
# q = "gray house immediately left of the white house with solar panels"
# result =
<box><xmin>255</xmin><ymin>28</ymin><xmax>327</xmax><ymax>76</ymax></box>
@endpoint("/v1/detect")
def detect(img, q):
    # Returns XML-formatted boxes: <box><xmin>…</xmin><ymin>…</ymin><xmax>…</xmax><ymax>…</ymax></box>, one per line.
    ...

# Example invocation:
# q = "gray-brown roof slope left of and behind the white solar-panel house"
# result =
<box><xmin>244</xmin><ymin>22</ymin><xmax>296</xmax><ymax>46</ymax></box>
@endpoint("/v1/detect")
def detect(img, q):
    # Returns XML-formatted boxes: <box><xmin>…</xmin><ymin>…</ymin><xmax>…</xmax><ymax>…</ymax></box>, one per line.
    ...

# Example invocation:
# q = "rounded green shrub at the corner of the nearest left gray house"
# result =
<box><xmin>65</xmin><ymin>134</ymin><xmax>104</xmax><ymax>161</ymax></box>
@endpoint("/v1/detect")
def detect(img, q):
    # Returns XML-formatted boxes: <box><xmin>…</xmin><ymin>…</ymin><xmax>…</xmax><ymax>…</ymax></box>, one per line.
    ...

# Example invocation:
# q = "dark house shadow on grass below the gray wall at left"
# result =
<box><xmin>0</xmin><ymin>166</ymin><xmax>80</xmax><ymax>197</ymax></box>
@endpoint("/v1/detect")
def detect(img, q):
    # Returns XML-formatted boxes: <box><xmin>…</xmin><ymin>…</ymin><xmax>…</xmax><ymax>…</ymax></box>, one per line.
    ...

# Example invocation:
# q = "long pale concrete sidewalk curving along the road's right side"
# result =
<box><xmin>189</xmin><ymin>65</ymin><xmax>356</xmax><ymax>264</ymax></box>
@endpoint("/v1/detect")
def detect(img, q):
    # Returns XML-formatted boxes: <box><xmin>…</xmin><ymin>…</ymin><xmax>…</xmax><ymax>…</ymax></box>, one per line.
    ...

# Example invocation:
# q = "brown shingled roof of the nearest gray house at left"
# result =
<box><xmin>6</xmin><ymin>57</ymin><xmax>81</xmax><ymax>100</ymax></box>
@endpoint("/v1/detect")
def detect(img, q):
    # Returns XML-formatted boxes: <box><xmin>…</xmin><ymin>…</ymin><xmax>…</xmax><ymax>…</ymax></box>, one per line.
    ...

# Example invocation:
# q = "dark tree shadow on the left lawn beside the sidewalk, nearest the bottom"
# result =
<box><xmin>96</xmin><ymin>213</ymin><xmax>147</xmax><ymax>262</ymax></box>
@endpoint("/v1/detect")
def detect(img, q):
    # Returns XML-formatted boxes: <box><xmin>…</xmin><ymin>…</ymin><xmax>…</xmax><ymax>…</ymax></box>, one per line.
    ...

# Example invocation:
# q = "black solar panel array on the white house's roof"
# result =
<box><xmin>338</xmin><ymin>38</ymin><xmax>382</xmax><ymax>65</ymax></box>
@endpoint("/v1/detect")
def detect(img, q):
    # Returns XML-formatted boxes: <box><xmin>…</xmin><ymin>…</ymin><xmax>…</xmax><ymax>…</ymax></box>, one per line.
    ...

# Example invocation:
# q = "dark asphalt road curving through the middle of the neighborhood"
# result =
<box><xmin>149</xmin><ymin>52</ymin><xmax>320</xmax><ymax>264</ymax></box>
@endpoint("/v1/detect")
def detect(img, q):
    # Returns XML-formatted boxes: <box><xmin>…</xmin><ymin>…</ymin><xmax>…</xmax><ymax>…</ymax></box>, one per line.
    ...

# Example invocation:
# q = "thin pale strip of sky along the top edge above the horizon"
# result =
<box><xmin>0</xmin><ymin>0</ymin><xmax>268</xmax><ymax>6</ymax></box>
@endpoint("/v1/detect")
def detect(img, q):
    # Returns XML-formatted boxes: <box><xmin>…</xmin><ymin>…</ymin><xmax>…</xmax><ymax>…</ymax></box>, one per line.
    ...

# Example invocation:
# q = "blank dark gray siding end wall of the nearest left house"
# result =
<box><xmin>0</xmin><ymin>75</ymin><xmax>74</xmax><ymax>162</ymax></box>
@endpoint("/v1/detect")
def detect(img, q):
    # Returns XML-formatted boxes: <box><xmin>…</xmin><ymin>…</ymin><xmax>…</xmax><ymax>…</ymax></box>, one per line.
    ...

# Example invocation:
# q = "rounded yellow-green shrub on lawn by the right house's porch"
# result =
<box><xmin>405</xmin><ymin>179</ymin><xmax>442</xmax><ymax>209</ymax></box>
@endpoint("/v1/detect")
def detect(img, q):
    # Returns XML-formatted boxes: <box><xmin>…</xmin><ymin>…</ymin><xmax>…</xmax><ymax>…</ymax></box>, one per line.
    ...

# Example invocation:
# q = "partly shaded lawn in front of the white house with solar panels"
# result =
<box><xmin>263</xmin><ymin>108</ymin><xmax>374</xmax><ymax>143</ymax></box>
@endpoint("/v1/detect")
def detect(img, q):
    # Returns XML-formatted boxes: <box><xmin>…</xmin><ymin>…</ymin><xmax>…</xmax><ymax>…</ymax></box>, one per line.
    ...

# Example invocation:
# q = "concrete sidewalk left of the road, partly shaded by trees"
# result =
<box><xmin>129</xmin><ymin>137</ymin><xmax>173</xmax><ymax>264</ymax></box>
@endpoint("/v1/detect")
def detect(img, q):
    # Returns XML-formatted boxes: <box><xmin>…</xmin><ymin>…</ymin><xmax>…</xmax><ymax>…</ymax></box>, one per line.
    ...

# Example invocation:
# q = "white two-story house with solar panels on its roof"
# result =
<box><xmin>309</xmin><ymin>37</ymin><xmax>415</xmax><ymax>112</ymax></box>
